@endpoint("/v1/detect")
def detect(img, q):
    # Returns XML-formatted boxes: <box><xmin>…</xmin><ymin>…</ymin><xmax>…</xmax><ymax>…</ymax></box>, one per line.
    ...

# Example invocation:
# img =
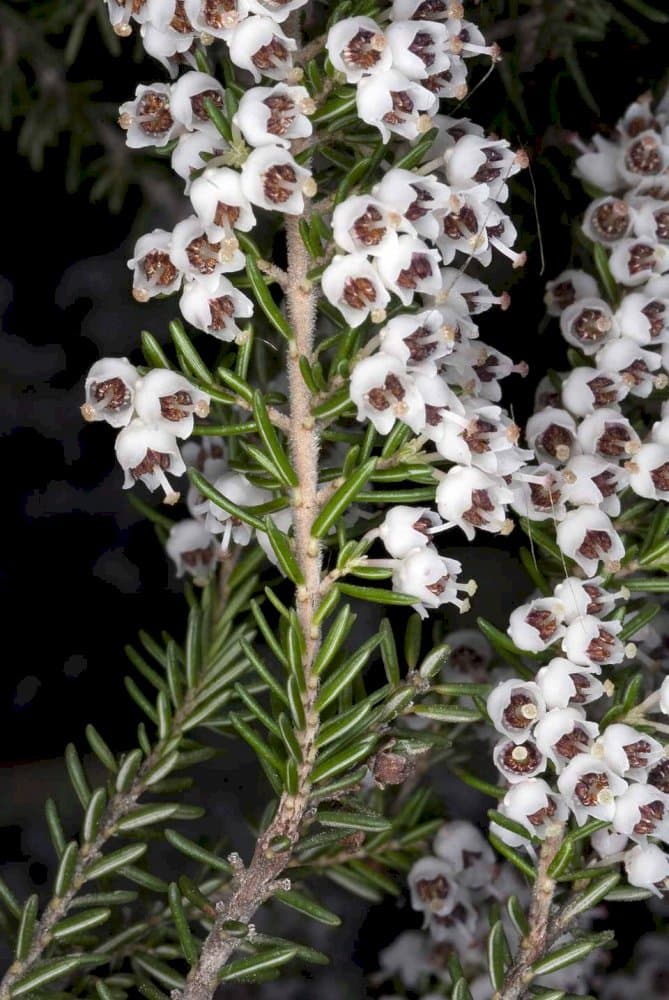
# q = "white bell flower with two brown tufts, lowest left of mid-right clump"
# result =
<box><xmin>350</xmin><ymin>351</ymin><xmax>425</xmax><ymax>434</ymax></box>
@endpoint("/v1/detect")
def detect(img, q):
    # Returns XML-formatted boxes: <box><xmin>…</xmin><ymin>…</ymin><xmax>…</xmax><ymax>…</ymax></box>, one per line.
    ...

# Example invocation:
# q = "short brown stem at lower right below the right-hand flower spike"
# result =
<box><xmin>493</xmin><ymin>825</ymin><xmax>564</xmax><ymax>1000</ymax></box>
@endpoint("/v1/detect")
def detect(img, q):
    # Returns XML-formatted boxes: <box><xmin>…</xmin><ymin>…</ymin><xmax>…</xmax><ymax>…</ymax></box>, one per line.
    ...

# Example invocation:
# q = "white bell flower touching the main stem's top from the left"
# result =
<box><xmin>242</xmin><ymin>146</ymin><xmax>316</xmax><ymax>215</ymax></box>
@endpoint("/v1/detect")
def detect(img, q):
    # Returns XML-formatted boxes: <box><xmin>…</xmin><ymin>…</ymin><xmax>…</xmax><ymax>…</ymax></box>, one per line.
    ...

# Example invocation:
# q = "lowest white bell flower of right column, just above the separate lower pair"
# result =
<box><xmin>436</xmin><ymin>465</ymin><xmax>513</xmax><ymax>541</ymax></box>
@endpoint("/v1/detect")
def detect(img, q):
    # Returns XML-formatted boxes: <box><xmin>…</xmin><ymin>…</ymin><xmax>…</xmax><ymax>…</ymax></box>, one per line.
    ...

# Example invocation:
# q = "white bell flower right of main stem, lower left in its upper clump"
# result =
<box><xmin>321</xmin><ymin>254</ymin><xmax>390</xmax><ymax>326</ymax></box>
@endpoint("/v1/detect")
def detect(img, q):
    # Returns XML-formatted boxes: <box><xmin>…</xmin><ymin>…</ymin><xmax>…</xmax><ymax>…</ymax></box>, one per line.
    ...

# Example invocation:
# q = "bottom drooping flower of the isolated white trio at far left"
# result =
<box><xmin>115</xmin><ymin>417</ymin><xmax>186</xmax><ymax>504</ymax></box>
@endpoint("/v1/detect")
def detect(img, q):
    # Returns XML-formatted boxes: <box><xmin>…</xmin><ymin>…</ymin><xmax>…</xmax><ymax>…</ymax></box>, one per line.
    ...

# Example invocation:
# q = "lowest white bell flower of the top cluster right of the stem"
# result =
<box><xmin>356</xmin><ymin>69</ymin><xmax>439</xmax><ymax>142</ymax></box>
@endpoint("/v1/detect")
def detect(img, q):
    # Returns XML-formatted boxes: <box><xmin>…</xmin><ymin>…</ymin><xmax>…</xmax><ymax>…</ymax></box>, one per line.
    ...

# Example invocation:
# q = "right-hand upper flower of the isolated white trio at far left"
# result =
<box><xmin>135</xmin><ymin>368</ymin><xmax>210</xmax><ymax>438</ymax></box>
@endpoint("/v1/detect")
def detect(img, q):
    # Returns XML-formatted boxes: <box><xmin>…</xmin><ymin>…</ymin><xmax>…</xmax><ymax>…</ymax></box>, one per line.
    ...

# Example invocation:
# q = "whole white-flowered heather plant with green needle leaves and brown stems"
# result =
<box><xmin>0</xmin><ymin>0</ymin><xmax>669</xmax><ymax>1000</ymax></box>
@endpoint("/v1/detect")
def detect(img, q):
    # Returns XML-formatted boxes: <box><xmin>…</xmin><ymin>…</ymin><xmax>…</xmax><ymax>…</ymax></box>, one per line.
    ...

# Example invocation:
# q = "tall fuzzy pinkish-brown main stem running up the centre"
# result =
<box><xmin>183</xmin><ymin>217</ymin><xmax>322</xmax><ymax>1000</ymax></box>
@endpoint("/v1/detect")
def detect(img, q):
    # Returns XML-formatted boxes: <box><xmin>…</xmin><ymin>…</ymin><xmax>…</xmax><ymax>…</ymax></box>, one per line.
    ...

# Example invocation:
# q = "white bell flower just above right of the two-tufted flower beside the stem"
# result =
<box><xmin>379</xmin><ymin>309</ymin><xmax>453</xmax><ymax>377</ymax></box>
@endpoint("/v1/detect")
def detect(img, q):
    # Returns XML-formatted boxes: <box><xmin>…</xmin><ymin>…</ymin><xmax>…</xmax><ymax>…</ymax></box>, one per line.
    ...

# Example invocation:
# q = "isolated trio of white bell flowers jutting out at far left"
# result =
<box><xmin>81</xmin><ymin>358</ymin><xmax>210</xmax><ymax>504</ymax></box>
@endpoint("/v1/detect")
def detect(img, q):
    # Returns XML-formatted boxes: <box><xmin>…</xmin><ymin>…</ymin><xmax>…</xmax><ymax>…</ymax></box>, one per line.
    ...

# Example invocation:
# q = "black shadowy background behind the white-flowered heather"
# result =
<box><xmin>0</xmin><ymin>5</ymin><xmax>667</xmax><ymax>995</ymax></box>
